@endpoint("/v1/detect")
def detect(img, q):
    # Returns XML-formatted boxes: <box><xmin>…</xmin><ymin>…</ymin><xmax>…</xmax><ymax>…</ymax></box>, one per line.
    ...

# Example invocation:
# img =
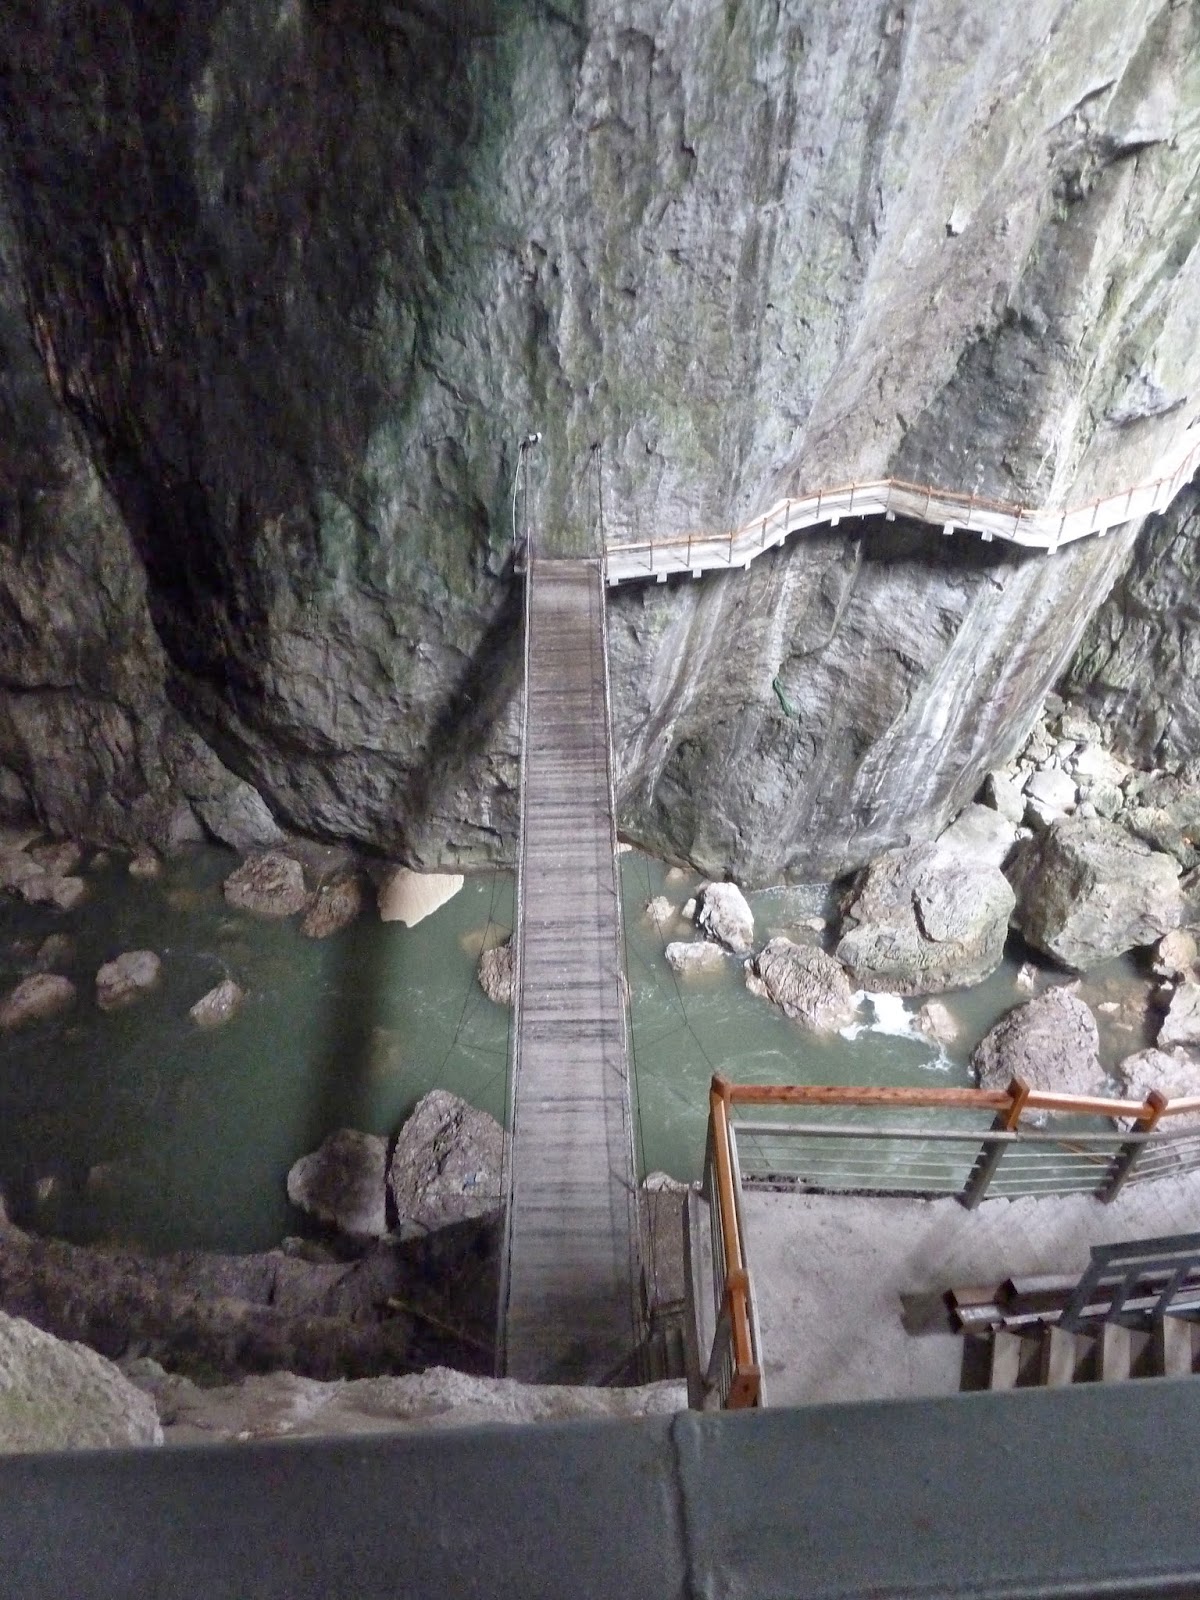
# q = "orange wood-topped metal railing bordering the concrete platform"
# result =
<box><xmin>693</xmin><ymin>1074</ymin><xmax>1200</xmax><ymax>1408</ymax></box>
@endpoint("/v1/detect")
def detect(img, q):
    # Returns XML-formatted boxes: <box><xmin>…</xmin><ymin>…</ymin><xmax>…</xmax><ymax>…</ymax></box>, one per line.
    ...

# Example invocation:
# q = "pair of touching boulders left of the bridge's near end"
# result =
<box><xmin>288</xmin><ymin>1090</ymin><xmax>509</xmax><ymax>1238</ymax></box>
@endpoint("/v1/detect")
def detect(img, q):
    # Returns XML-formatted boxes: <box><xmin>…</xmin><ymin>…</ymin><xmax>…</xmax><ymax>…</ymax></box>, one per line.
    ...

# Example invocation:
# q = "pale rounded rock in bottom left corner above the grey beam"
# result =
<box><xmin>0</xmin><ymin>1312</ymin><xmax>163</xmax><ymax>1454</ymax></box>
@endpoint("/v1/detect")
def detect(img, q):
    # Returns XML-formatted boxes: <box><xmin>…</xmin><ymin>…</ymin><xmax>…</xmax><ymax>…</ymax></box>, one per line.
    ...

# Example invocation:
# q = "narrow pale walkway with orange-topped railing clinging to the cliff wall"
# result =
<box><xmin>605</xmin><ymin>434</ymin><xmax>1200</xmax><ymax>586</ymax></box>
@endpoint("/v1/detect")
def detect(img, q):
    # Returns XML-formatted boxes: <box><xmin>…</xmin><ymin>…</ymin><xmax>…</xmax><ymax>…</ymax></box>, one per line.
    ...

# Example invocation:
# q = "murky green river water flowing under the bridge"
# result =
<box><xmin>0</xmin><ymin>848</ymin><xmax>1136</xmax><ymax>1251</ymax></box>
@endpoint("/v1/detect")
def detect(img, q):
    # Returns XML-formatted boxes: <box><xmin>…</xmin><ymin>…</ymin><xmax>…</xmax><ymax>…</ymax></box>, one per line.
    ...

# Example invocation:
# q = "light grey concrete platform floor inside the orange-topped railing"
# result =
<box><xmin>744</xmin><ymin>1173</ymin><xmax>1200</xmax><ymax>1406</ymax></box>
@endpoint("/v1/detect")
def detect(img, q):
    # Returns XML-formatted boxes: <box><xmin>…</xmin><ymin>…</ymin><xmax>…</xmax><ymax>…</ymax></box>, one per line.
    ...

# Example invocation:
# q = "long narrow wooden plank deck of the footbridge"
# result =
<box><xmin>499</xmin><ymin>558</ymin><xmax>642</xmax><ymax>1382</ymax></box>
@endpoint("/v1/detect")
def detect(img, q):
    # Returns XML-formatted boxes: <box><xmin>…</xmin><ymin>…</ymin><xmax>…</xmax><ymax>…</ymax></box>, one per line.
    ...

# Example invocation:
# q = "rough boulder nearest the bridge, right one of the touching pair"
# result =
<box><xmin>387</xmin><ymin>1090</ymin><xmax>509</xmax><ymax>1229</ymax></box>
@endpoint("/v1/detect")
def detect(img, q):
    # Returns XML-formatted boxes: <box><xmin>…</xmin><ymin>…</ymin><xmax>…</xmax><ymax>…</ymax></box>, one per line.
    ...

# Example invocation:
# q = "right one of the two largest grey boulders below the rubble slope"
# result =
<box><xmin>1011</xmin><ymin>818</ymin><xmax>1182</xmax><ymax>971</ymax></box>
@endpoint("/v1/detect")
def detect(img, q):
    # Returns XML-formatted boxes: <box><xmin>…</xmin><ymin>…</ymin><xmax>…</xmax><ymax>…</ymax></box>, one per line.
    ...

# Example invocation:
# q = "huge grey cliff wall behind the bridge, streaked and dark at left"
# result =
<box><xmin>0</xmin><ymin>0</ymin><xmax>1200</xmax><ymax>880</ymax></box>
